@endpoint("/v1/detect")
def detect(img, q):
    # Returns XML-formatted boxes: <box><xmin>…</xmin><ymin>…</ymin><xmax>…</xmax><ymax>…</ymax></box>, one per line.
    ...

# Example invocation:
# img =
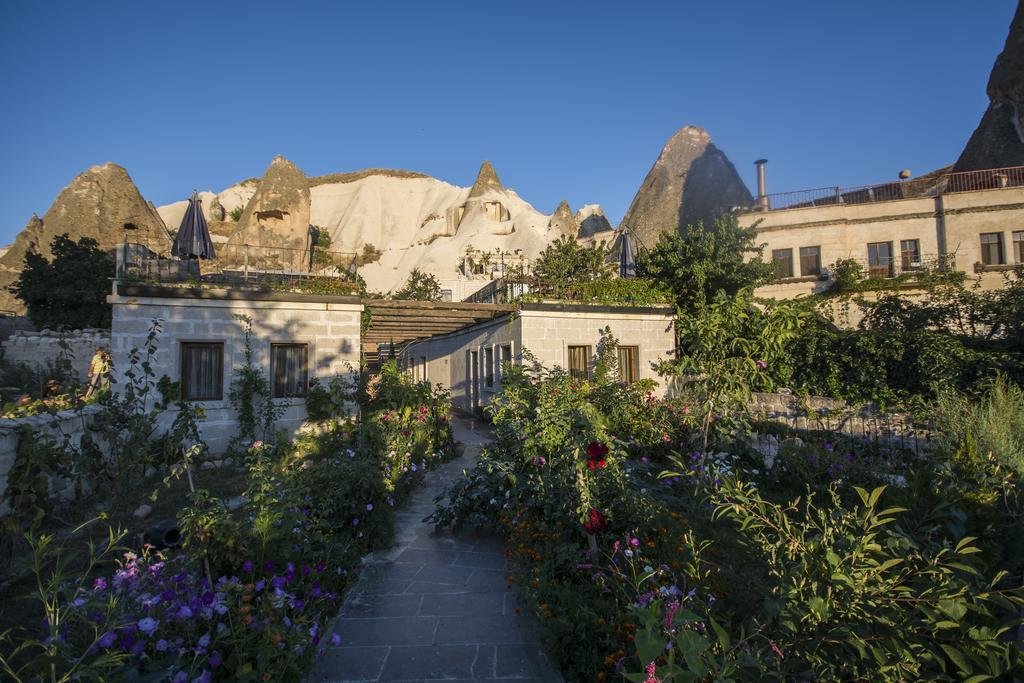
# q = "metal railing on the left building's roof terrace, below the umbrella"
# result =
<box><xmin>117</xmin><ymin>244</ymin><xmax>358</xmax><ymax>291</ymax></box>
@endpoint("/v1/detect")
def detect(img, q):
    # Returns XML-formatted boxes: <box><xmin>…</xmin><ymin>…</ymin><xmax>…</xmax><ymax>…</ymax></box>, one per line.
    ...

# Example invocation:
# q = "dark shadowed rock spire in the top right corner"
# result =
<box><xmin>953</xmin><ymin>0</ymin><xmax>1024</xmax><ymax>171</ymax></box>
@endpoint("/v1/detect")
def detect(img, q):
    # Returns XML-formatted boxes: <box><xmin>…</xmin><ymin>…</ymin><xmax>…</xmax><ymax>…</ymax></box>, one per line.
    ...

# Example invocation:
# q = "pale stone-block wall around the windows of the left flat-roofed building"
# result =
<box><xmin>109</xmin><ymin>285</ymin><xmax>362</xmax><ymax>453</ymax></box>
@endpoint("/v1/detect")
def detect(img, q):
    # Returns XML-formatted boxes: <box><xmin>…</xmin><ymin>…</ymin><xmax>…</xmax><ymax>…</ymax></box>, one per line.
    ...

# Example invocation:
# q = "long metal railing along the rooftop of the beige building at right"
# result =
<box><xmin>752</xmin><ymin>166</ymin><xmax>1024</xmax><ymax>211</ymax></box>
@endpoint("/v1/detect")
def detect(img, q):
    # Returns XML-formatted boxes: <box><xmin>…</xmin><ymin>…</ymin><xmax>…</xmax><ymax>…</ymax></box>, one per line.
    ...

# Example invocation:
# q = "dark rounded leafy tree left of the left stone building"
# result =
<box><xmin>8</xmin><ymin>232</ymin><xmax>114</xmax><ymax>330</ymax></box>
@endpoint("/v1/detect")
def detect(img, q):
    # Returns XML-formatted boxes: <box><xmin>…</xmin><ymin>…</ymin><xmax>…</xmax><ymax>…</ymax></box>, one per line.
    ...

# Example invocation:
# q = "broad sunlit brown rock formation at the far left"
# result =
<box><xmin>0</xmin><ymin>163</ymin><xmax>170</xmax><ymax>312</ymax></box>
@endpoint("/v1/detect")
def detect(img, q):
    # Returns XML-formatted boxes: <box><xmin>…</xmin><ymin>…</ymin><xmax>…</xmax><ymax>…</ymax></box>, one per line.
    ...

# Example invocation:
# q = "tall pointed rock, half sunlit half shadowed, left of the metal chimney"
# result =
<box><xmin>622</xmin><ymin>126</ymin><xmax>753</xmax><ymax>249</ymax></box>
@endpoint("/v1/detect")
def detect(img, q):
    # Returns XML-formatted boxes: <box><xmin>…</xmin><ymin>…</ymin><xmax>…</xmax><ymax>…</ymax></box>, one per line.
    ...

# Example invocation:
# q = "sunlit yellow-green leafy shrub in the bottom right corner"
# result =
<box><xmin>712</xmin><ymin>479</ymin><xmax>1024</xmax><ymax>680</ymax></box>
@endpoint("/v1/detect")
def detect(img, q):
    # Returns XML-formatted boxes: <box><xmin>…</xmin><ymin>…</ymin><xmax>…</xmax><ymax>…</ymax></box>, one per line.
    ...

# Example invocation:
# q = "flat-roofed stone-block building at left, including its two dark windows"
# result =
<box><xmin>109</xmin><ymin>284</ymin><xmax>362</xmax><ymax>453</ymax></box>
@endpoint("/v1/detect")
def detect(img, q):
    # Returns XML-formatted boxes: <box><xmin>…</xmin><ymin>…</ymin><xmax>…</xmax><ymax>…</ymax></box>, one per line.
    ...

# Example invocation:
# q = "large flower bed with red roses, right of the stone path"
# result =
<box><xmin>434</xmin><ymin>360</ymin><xmax>1024</xmax><ymax>683</ymax></box>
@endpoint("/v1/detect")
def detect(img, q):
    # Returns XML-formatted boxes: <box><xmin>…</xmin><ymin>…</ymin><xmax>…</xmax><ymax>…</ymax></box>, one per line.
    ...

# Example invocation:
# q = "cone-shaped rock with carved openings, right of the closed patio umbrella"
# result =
<box><xmin>222</xmin><ymin>156</ymin><xmax>310</xmax><ymax>267</ymax></box>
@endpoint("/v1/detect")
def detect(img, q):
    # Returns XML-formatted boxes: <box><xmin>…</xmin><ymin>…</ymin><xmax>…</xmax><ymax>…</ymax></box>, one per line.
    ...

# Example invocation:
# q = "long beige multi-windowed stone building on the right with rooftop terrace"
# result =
<box><xmin>739</xmin><ymin>167</ymin><xmax>1024</xmax><ymax>298</ymax></box>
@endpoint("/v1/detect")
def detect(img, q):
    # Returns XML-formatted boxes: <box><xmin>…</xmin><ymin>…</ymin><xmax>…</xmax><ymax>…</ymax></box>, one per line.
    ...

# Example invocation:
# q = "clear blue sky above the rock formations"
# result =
<box><xmin>0</xmin><ymin>0</ymin><xmax>1016</xmax><ymax>243</ymax></box>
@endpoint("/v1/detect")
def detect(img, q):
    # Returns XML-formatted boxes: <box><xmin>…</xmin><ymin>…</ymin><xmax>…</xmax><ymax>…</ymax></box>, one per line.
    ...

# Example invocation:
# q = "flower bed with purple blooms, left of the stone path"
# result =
<box><xmin>0</xmin><ymin>360</ymin><xmax>452</xmax><ymax>681</ymax></box>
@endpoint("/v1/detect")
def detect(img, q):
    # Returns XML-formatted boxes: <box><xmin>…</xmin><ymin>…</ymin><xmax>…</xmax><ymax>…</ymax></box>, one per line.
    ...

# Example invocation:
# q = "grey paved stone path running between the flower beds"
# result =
<box><xmin>309</xmin><ymin>419</ymin><xmax>562</xmax><ymax>683</ymax></box>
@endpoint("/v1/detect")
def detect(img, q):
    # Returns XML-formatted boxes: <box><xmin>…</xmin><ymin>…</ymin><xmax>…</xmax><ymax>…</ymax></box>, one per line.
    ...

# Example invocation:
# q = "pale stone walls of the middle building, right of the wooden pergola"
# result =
<box><xmin>401</xmin><ymin>303</ymin><xmax>675</xmax><ymax>411</ymax></box>
